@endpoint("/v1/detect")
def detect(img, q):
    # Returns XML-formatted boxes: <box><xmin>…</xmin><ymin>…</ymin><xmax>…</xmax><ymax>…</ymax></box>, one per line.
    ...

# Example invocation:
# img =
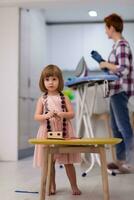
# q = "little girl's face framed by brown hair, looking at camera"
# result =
<box><xmin>44</xmin><ymin>76</ymin><xmax>59</xmax><ymax>92</ymax></box>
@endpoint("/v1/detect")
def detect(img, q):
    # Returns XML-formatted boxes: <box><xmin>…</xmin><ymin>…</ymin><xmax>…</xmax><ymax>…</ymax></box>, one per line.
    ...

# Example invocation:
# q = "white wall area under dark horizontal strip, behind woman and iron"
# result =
<box><xmin>48</xmin><ymin>23</ymin><xmax>134</xmax><ymax>70</ymax></box>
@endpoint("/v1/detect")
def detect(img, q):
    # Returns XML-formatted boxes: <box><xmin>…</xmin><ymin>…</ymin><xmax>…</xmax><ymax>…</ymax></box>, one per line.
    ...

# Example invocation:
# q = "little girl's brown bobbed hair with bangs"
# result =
<box><xmin>39</xmin><ymin>65</ymin><xmax>64</xmax><ymax>92</ymax></box>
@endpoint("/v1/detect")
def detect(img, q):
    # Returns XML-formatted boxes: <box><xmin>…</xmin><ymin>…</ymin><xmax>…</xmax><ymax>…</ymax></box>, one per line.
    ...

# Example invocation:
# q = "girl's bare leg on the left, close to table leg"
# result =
<box><xmin>50</xmin><ymin>162</ymin><xmax>56</xmax><ymax>194</ymax></box>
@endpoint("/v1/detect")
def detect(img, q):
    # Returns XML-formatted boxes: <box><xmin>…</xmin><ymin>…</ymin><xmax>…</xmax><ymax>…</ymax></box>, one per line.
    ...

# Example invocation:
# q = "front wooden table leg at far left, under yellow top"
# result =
<box><xmin>40</xmin><ymin>147</ymin><xmax>49</xmax><ymax>200</ymax></box>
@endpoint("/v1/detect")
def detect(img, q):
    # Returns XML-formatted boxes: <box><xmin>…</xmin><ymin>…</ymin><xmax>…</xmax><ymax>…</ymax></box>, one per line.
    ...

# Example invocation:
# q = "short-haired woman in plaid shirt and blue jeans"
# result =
<box><xmin>100</xmin><ymin>14</ymin><xmax>134</xmax><ymax>173</ymax></box>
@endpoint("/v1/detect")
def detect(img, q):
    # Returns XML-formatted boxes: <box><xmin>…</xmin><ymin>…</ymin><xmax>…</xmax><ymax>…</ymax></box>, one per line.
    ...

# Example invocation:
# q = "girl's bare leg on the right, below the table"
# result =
<box><xmin>65</xmin><ymin>164</ymin><xmax>81</xmax><ymax>195</ymax></box>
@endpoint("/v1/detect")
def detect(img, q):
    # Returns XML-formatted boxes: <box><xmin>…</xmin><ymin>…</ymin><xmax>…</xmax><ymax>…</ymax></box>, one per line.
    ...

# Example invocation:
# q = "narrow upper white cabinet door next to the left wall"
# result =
<box><xmin>19</xmin><ymin>10</ymin><xmax>31</xmax><ymax>97</ymax></box>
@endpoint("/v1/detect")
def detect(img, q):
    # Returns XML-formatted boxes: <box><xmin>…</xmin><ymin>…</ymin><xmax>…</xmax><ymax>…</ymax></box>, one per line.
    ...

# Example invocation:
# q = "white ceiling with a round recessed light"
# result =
<box><xmin>0</xmin><ymin>0</ymin><xmax>134</xmax><ymax>23</ymax></box>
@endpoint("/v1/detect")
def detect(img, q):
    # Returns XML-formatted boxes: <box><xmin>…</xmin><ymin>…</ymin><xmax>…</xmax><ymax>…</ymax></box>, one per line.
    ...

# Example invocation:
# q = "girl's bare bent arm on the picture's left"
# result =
<box><xmin>34</xmin><ymin>97</ymin><xmax>54</xmax><ymax>122</ymax></box>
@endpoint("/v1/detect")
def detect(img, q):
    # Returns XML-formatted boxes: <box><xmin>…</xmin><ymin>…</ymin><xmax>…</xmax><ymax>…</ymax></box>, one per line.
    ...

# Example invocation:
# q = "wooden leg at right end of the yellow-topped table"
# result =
<box><xmin>99</xmin><ymin>146</ymin><xmax>109</xmax><ymax>200</ymax></box>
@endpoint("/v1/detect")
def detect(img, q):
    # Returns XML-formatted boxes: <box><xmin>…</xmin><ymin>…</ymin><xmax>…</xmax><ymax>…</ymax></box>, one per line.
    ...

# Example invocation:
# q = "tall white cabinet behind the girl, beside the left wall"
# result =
<box><xmin>18</xmin><ymin>9</ymin><xmax>46</xmax><ymax>158</ymax></box>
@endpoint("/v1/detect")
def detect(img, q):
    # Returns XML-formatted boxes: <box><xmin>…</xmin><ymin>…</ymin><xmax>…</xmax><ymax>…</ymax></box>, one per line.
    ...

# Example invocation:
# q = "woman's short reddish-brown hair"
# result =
<box><xmin>104</xmin><ymin>13</ymin><xmax>123</xmax><ymax>33</ymax></box>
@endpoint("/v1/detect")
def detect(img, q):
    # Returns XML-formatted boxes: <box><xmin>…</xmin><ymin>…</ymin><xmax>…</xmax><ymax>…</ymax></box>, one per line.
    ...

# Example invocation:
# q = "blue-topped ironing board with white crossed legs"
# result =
<box><xmin>65</xmin><ymin>71</ymin><xmax>119</xmax><ymax>176</ymax></box>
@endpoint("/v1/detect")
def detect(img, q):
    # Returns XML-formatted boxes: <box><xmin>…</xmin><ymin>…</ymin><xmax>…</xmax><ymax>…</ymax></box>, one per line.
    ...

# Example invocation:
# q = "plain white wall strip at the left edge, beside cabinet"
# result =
<box><xmin>0</xmin><ymin>7</ymin><xmax>19</xmax><ymax>160</ymax></box>
